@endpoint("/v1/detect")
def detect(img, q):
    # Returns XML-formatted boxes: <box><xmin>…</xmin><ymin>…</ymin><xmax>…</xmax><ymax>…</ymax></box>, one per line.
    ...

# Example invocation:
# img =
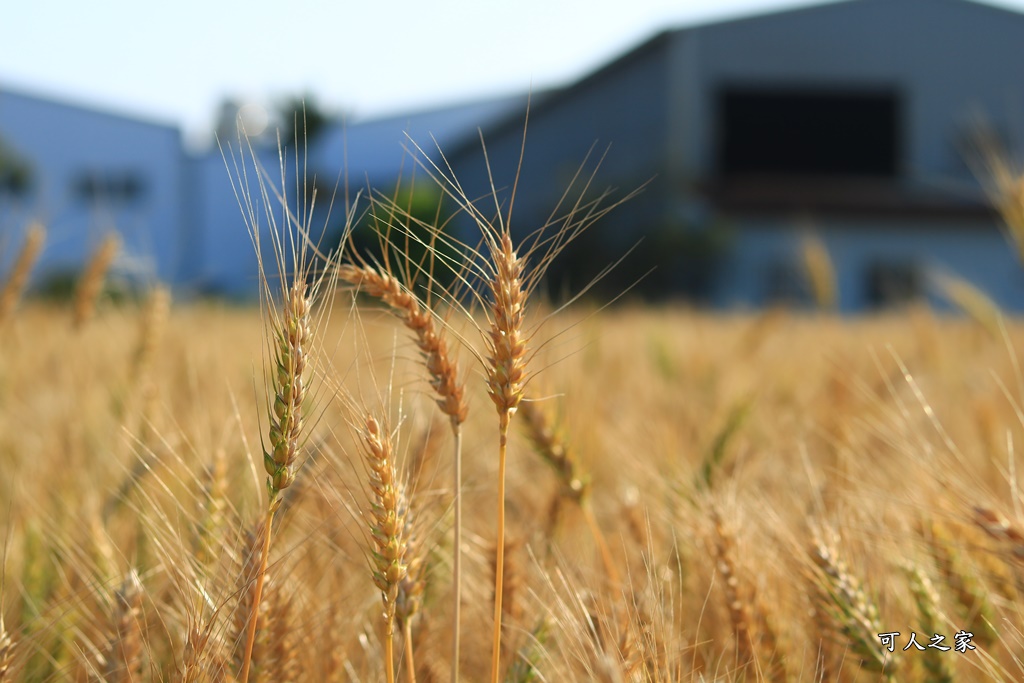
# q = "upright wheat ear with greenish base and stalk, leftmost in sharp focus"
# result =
<box><xmin>239</xmin><ymin>275</ymin><xmax>312</xmax><ymax>683</ymax></box>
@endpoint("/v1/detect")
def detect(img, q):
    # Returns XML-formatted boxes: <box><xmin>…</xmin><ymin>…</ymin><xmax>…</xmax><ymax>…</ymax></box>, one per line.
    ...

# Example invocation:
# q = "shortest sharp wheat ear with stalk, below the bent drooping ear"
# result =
<box><xmin>362</xmin><ymin>417</ymin><xmax>409</xmax><ymax>683</ymax></box>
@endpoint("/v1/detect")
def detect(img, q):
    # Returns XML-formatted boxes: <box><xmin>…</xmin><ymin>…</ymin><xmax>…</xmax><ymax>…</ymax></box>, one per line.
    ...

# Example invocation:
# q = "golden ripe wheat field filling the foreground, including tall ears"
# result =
<box><xmin>0</xmin><ymin>140</ymin><xmax>1024</xmax><ymax>683</ymax></box>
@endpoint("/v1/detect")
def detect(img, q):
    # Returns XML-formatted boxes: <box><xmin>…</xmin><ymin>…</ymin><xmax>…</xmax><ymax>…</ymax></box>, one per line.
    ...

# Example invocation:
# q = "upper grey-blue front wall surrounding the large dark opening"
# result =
<box><xmin>675</xmin><ymin>0</ymin><xmax>1024</xmax><ymax>180</ymax></box>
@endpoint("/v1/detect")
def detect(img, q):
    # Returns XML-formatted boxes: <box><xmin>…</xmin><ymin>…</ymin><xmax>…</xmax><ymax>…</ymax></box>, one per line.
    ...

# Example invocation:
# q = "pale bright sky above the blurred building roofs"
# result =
<box><xmin>0</xmin><ymin>0</ymin><xmax>1024</xmax><ymax>147</ymax></box>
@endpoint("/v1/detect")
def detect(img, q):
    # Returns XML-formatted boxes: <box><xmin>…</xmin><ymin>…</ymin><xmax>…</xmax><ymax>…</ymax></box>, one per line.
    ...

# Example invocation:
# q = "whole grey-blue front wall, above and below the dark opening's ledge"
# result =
<box><xmin>671</xmin><ymin>0</ymin><xmax>1024</xmax><ymax>310</ymax></box>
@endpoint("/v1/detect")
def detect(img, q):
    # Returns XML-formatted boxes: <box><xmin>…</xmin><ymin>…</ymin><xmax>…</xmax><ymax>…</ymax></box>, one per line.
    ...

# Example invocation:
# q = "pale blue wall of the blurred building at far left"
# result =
<box><xmin>0</xmin><ymin>90</ymin><xmax>186</xmax><ymax>283</ymax></box>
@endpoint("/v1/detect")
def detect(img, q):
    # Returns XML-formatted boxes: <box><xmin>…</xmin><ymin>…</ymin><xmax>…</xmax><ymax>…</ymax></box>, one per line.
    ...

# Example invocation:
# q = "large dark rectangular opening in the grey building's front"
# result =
<box><xmin>717</xmin><ymin>87</ymin><xmax>900</xmax><ymax>177</ymax></box>
